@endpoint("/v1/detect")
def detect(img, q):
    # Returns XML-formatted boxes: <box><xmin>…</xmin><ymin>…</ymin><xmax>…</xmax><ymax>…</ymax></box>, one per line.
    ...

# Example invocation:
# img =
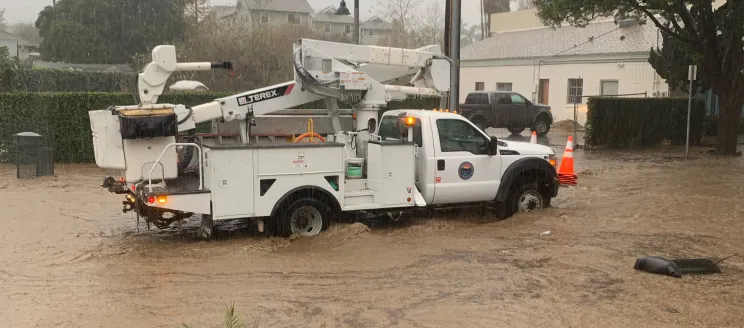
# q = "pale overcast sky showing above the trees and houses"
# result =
<box><xmin>0</xmin><ymin>0</ymin><xmax>488</xmax><ymax>25</ymax></box>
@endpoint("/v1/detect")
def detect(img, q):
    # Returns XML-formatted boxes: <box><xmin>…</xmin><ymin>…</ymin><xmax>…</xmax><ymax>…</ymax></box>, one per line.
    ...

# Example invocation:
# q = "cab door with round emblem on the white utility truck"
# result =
<box><xmin>432</xmin><ymin>118</ymin><xmax>501</xmax><ymax>204</ymax></box>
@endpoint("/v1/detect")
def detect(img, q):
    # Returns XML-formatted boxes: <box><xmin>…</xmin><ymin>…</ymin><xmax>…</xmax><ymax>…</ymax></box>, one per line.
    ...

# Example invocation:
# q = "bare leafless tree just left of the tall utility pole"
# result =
<box><xmin>377</xmin><ymin>0</ymin><xmax>421</xmax><ymax>48</ymax></box>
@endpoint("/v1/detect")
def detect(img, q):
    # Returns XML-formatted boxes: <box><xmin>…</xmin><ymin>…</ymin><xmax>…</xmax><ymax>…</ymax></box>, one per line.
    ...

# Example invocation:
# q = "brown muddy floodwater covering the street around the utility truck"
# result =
<box><xmin>0</xmin><ymin>139</ymin><xmax>744</xmax><ymax>328</ymax></box>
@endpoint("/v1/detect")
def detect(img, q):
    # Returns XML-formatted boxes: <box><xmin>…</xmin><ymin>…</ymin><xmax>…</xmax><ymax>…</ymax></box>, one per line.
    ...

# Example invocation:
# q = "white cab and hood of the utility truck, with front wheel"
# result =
<box><xmin>377</xmin><ymin>110</ymin><xmax>558</xmax><ymax>216</ymax></box>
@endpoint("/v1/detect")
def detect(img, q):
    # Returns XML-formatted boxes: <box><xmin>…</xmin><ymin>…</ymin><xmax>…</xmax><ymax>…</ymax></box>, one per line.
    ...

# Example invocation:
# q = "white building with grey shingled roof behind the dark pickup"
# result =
<box><xmin>460</xmin><ymin>21</ymin><xmax>669</xmax><ymax>125</ymax></box>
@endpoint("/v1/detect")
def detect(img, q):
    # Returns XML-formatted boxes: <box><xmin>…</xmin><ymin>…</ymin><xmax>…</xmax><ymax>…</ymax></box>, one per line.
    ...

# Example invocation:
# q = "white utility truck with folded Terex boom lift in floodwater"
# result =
<box><xmin>89</xmin><ymin>39</ymin><xmax>558</xmax><ymax>238</ymax></box>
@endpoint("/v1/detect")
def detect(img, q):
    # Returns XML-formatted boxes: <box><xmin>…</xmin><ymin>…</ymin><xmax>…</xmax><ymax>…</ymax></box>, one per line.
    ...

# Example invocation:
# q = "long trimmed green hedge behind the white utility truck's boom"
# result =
<box><xmin>0</xmin><ymin>92</ymin><xmax>439</xmax><ymax>163</ymax></box>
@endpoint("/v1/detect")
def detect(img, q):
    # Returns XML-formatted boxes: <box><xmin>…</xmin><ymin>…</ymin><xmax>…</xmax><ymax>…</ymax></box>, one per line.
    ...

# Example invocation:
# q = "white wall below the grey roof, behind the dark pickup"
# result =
<box><xmin>460</xmin><ymin>54</ymin><xmax>668</xmax><ymax>125</ymax></box>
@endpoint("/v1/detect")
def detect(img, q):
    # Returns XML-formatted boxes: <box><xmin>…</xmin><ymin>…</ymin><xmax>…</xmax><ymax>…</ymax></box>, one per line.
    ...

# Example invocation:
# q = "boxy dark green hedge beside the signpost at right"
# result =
<box><xmin>586</xmin><ymin>97</ymin><xmax>705</xmax><ymax>148</ymax></box>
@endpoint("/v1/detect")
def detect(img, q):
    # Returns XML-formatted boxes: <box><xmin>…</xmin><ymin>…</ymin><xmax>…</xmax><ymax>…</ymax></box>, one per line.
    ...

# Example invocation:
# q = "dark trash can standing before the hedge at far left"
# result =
<box><xmin>13</xmin><ymin>132</ymin><xmax>54</xmax><ymax>179</ymax></box>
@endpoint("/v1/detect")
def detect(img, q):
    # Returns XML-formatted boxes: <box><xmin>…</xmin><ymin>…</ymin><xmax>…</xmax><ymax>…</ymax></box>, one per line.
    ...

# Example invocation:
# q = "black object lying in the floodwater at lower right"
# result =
<box><xmin>633</xmin><ymin>255</ymin><xmax>735</xmax><ymax>278</ymax></box>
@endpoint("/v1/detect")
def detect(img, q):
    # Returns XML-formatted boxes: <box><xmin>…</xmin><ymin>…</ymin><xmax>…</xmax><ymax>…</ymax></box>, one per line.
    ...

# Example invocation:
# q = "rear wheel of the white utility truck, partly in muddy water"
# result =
<box><xmin>276</xmin><ymin>198</ymin><xmax>331</xmax><ymax>237</ymax></box>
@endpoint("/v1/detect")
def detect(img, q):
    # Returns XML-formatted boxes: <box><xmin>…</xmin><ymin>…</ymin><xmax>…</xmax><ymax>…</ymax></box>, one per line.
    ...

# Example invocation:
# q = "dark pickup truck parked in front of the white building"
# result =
<box><xmin>460</xmin><ymin>91</ymin><xmax>553</xmax><ymax>136</ymax></box>
